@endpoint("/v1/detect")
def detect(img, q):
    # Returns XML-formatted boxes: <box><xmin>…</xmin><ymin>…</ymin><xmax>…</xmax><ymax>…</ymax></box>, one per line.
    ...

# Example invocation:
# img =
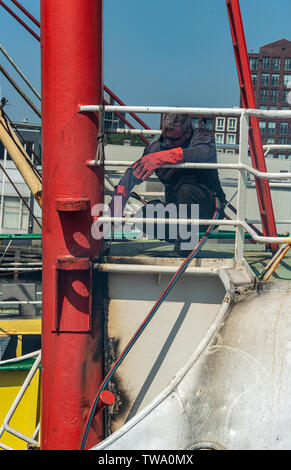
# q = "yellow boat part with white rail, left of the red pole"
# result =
<box><xmin>0</xmin><ymin>318</ymin><xmax>41</xmax><ymax>450</ymax></box>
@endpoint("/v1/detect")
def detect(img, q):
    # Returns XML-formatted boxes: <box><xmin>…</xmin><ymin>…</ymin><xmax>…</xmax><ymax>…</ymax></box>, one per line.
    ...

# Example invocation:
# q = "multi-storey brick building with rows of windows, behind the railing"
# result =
<box><xmin>193</xmin><ymin>39</ymin><xmax>291</xmax><ymax>159</ymax></box>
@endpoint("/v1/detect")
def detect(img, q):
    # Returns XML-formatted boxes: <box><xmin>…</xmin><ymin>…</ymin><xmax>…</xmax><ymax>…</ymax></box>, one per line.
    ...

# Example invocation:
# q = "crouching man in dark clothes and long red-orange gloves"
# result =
<box><xmin>109</xmin><ymin>114</ymin><xmax>226</xmax><ymax>256</ymax></box>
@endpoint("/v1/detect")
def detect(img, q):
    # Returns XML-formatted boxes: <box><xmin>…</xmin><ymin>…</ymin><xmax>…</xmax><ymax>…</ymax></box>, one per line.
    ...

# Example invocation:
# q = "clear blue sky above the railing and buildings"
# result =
<box><xmin>0</xmin><ymin>0</ymin><xmax>291</xmax><ymax>127</ymax></box>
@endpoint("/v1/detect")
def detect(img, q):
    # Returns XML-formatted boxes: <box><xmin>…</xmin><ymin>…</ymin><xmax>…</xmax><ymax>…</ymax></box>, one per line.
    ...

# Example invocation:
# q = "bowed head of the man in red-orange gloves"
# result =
<box><xmin>162</xmin><ymin>113</ymin><xmax>193</xmax><ymax>148</ymax></box>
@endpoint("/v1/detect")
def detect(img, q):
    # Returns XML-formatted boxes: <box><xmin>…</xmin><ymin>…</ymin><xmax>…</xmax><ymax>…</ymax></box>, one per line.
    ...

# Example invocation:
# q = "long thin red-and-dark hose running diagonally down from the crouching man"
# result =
<box><xmin>80</xmin><ymin>198</ymin><xmax>221</xmax><ymax>450</ymax></box>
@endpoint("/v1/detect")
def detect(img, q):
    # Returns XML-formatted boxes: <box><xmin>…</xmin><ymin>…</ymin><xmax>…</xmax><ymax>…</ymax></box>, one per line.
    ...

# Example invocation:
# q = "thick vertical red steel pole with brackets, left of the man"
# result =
<box><xmin>41</xmin><ymin>0</ymin><xmax>104</xmax><ymax>450</ymax></box>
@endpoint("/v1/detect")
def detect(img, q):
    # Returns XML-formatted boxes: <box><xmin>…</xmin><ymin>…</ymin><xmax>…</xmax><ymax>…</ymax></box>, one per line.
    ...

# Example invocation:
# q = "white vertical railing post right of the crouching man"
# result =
<box><xmin>235</xmin><ymin>111</ymin><xmax>249</xmax><ymax>264</ymax></box>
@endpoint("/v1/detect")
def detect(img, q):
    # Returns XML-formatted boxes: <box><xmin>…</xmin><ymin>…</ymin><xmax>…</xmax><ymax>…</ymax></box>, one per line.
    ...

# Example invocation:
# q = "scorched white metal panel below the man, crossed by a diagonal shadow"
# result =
<box><xmin>99</xmin><ymin>259</ymin><xmax>238</xmax><ymax>429</ymax></box>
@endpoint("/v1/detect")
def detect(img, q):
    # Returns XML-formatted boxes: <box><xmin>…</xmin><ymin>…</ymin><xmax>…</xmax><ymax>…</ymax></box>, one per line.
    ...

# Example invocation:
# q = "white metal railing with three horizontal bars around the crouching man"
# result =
<box><xmin>79</xmin><ymin>105</ymin><xmax>291</xmax><ymax>262</ymax></box>
